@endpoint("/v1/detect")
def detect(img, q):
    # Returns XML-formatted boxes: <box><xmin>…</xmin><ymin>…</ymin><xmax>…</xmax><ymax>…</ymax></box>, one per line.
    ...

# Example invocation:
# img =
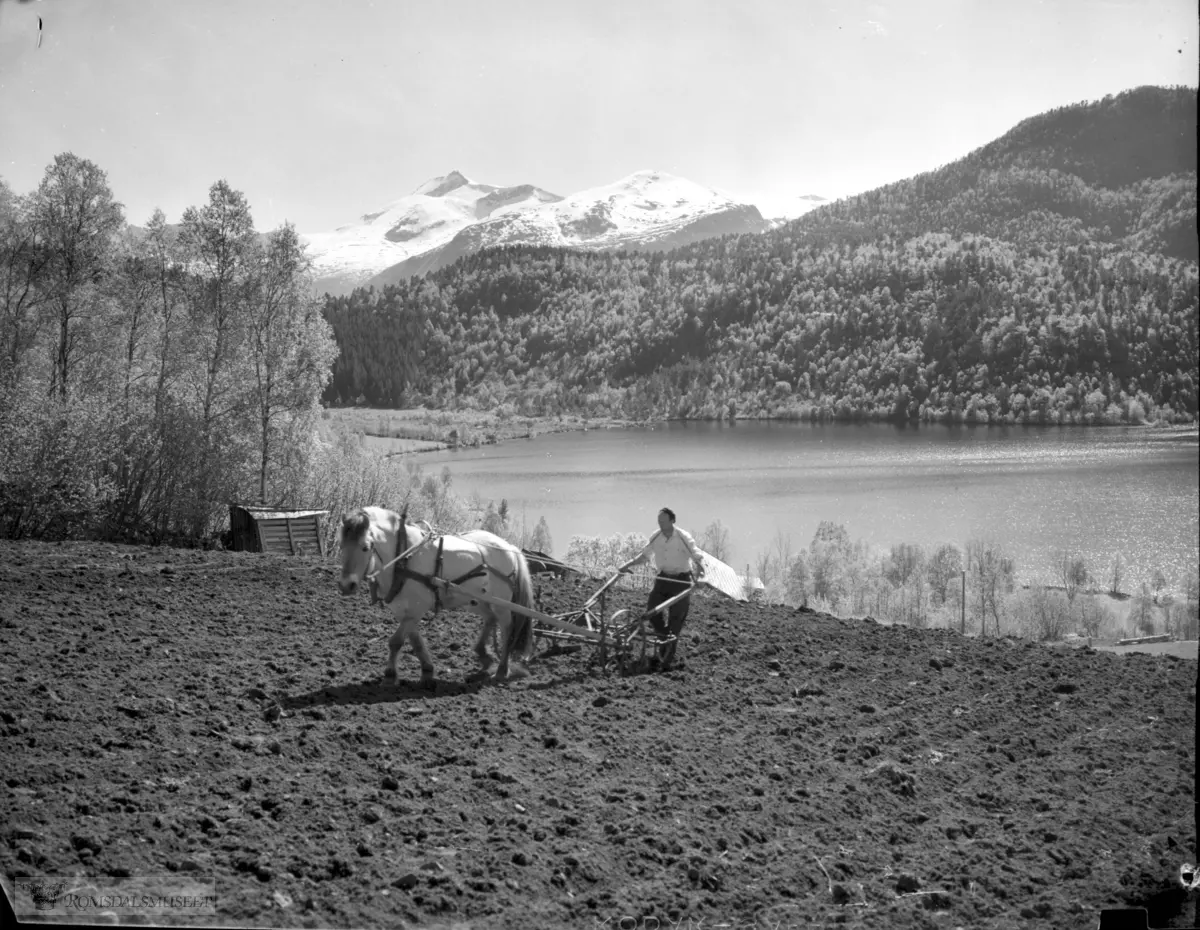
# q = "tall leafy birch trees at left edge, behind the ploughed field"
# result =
<box><xmin>0</xmin><ymin>152</ymin><xmax>336</xmax><ymax>540</ymax></box>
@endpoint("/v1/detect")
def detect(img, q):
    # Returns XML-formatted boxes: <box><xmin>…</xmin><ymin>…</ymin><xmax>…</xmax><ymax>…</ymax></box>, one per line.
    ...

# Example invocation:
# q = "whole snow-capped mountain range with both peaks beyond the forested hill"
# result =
<box><xmin>307</xmin><ymin>170</ymin><xmax>769</xmax><ymax>294</ymax></box>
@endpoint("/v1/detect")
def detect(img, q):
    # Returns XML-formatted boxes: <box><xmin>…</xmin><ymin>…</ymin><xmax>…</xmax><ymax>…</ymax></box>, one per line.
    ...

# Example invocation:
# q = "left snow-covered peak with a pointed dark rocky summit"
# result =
<box><xmin>304</xmin><ymin>170</ymin><xmax>562</xmax><ymax>294</ymax></box>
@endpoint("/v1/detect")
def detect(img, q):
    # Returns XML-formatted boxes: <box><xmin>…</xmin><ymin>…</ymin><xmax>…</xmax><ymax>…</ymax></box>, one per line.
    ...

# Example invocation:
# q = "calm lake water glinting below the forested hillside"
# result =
<box><xmin>416</xmin><ymin>422</ymin><xmax>1200</xmax><ymax>590</ymax></box>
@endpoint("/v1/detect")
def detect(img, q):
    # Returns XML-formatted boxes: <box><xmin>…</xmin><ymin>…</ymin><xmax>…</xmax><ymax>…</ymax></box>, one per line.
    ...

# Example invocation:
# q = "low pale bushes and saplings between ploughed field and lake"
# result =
<box><xmin>565</xmin><ymin>521</ymin><xmax>1200</xmax><ymax>641</ymax></box>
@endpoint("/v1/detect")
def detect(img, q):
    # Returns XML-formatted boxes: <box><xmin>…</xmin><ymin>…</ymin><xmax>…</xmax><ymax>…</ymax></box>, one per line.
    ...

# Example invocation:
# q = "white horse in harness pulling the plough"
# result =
<box><xmin>337</xmin><ymin>506</ymin><xmax>533</xmax><ymax>688</ymax></box>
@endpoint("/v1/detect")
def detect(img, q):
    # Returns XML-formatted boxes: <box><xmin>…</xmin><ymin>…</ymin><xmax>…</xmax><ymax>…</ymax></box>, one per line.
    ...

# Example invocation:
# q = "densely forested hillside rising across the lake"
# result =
<box><xmin>325</xmin><ymin>88</ymin><xmax>1198</xmax><ymax>422</ymax></box>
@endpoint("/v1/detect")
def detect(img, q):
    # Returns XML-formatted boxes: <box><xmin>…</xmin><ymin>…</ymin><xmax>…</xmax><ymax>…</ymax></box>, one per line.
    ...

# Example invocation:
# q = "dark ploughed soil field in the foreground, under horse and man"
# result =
<box><xmin>0</xmin><ymin>544</ymin><xmax>1196</xmax><ymax>929</ymax></box>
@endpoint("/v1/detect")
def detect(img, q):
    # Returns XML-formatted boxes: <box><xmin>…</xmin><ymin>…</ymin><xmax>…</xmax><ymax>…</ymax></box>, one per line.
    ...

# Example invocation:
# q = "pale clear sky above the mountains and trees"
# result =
<box><xmin>0</xmin><ymin>0</ymin><xmax>1200</xmax><ymax>233</ymax></box>
